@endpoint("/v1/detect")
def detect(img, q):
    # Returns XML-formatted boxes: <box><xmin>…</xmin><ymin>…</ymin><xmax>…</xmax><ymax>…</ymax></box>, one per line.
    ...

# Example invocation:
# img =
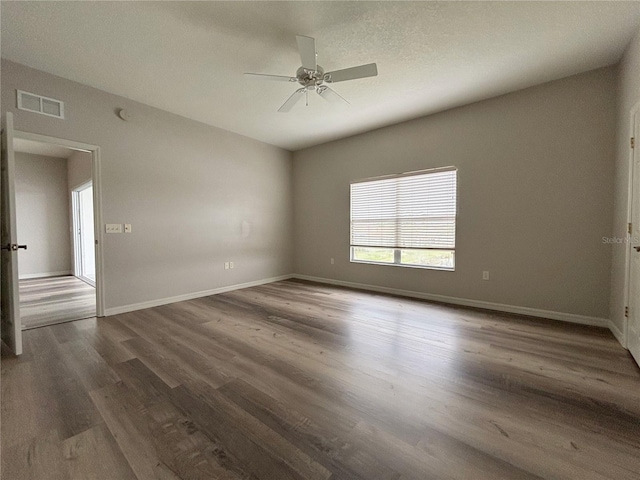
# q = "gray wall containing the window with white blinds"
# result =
<box><xmin>294</xmin><ymin>68</ymin><xmax>616</xmax><ymax>318</ymax></box>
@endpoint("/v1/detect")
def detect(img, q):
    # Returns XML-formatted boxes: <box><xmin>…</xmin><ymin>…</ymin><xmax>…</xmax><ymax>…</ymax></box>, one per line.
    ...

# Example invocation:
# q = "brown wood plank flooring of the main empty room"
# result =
<box><xmin>1</xmin><ymin>280</ymin><xmax>640</xmax><ymax>480</ymax></box>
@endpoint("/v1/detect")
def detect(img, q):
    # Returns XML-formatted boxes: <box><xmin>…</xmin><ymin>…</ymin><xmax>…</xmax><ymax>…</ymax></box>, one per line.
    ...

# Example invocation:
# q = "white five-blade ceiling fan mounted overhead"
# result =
<box><xmin>244</xmin><ymin>35</ymin><xmax>378</xmax><ymax>113</ymax></box>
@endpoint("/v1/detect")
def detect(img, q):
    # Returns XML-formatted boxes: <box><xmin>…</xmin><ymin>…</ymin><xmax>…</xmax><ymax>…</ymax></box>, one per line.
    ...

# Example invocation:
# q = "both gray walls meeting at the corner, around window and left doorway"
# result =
<box><xmin>2</xmin><ymin>61</ymin><xmax>617</xmax><ymax>318</ymax></box>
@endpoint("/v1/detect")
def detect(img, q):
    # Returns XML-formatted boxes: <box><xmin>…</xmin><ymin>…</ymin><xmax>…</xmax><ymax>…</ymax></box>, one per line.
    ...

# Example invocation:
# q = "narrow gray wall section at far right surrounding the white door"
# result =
<box><xmin>610</xmin><ymin>26</ymin><xmax>640</xmax><ymax>335</ymax></box>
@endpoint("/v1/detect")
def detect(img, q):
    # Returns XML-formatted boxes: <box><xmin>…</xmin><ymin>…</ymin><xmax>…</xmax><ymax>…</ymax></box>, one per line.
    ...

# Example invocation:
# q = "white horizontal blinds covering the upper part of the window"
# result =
<box><xmin>351</xmin><ymin>167</ymin><xmax>457</xmax><ymax>250</ymax></box>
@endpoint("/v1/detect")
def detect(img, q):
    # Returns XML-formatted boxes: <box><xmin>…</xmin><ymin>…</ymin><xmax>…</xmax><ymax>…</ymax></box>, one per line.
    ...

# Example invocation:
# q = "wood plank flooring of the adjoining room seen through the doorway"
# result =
<box><xmin>19</xmin><ymin>276</ymin><xmax>96</xmax><ymax>329</ymax></box>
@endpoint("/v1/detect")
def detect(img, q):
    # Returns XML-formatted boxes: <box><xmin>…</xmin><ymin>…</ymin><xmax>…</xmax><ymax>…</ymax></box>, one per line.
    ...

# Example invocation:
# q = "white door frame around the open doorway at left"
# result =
<box><xmin>13</xmin><ymin>130</ymin><xmax>105</xmax><ymax>317</ymax></box>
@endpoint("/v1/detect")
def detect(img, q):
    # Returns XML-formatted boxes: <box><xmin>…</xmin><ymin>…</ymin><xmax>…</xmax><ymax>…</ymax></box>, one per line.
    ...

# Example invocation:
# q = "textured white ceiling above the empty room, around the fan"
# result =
<box><xmin>1</xmin><ymin>1</ymin><xmax>640</xmax><ymax>150</ymax></box>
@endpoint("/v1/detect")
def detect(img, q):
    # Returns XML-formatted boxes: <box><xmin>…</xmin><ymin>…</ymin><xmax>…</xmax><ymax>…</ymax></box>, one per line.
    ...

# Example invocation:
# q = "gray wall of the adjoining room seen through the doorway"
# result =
<box><xmin>15</xmin><ymin>153</ymin><xmax>71</xmax><ymax>278</ymax></box>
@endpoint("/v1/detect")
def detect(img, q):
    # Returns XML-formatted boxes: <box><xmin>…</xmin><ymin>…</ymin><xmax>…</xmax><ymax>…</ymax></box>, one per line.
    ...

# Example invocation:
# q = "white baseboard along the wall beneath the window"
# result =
<box><xmin>292</xmin><ymin>274</ymin><xmax>615</xmax><ymax>328</ymax></box>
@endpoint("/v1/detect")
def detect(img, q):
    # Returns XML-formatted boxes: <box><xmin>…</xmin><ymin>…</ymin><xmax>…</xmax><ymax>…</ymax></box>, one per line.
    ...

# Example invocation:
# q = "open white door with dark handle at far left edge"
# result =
<box><xmin>0</xmin><ymin>113</ymin><xmax>26</xmax><ymax>355</ymax></box>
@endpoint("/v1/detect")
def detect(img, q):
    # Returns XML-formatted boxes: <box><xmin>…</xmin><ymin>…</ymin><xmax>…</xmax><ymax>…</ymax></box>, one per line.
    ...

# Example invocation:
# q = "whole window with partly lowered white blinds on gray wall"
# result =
<box><xmin>351</xmin><ymin>167</ymin><xmax>457</xmax><ymax>270</ymax></box>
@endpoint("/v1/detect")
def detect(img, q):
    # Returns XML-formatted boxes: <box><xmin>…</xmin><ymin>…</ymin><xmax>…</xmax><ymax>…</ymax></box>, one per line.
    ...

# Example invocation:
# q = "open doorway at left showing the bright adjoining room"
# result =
<box><xmin>14</xmin><ymin>138</ymin><xmax>96</xmax><ymax>329</ymax></box>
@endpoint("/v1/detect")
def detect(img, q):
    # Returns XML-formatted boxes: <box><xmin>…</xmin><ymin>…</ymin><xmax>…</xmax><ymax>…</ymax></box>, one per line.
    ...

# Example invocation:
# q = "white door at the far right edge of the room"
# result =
<box><xmin>627</xmin><ymin>110</ymin><xmax>640</xmax><ymax>365</ymax></box>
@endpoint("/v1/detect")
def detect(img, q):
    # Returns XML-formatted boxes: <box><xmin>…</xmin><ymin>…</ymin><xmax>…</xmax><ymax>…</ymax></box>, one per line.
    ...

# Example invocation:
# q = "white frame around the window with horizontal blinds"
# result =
<box><xmin>349</xmin><ymin>165</ymin><xmax>459</xmax><ymax>272</ymax></box>
